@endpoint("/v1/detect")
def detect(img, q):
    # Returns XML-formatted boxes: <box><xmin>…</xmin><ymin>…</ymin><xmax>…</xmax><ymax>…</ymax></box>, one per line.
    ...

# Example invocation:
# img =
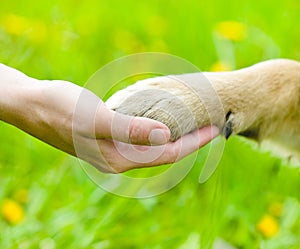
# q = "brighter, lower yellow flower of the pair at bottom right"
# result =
<box><xmin>257</xmin><ymin>214</ymin><xmax>279</xmax><ymax>238</ymax></box>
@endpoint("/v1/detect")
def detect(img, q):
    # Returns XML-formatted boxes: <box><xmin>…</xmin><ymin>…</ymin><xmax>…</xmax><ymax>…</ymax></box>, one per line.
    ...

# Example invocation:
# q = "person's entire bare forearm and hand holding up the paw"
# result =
<box><xmin>0</xmin><ymin>64</ymin><xmax>219</xmax><ymax>173</ymax></box>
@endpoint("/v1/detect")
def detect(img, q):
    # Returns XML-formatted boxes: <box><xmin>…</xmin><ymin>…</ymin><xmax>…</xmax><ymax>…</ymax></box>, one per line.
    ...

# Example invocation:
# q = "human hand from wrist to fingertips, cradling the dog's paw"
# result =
<box><xmin>38</xmin><ymin>81</ymin><xmax>218</xmax><ymax>173</ymax></box>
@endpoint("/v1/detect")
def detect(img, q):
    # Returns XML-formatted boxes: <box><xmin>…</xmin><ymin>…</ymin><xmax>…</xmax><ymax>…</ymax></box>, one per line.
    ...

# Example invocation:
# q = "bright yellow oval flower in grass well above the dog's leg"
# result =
<box><xmin>215</xmin><ymin>21</ymin><xmax>247</xmax><ymax>41</ymax></box>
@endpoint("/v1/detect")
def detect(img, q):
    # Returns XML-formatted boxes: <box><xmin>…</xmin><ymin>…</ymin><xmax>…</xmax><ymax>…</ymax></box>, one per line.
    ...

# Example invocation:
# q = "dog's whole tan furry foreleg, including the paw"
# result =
<box><xmin>107</xmin><ymin>59</ymin><xmax>300</xmax><ymax>158</ymax></box>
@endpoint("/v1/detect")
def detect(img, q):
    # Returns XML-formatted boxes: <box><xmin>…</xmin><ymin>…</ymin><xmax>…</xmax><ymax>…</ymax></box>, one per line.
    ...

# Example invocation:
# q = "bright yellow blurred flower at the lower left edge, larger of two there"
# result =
<box><xmin>1</xmin><ymin>199</ymin><xmax>25</xmax><ymax>224</ymax></box>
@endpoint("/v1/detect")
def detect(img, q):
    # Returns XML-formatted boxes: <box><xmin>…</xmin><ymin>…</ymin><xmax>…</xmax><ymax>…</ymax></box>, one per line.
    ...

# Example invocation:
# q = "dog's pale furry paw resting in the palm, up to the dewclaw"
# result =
<box><xmin>106</xmin><ymin>76</ymin><xmax>226</xmax><ymax>141</ymax></box>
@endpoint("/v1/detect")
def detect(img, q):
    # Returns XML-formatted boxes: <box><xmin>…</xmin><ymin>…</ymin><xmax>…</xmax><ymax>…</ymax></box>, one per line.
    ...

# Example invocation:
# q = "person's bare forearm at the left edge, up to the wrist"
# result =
<box><xmin>0</xmin><ymin>64</ymin><xmax>73</xmax><ymax>154</ymax></box>
